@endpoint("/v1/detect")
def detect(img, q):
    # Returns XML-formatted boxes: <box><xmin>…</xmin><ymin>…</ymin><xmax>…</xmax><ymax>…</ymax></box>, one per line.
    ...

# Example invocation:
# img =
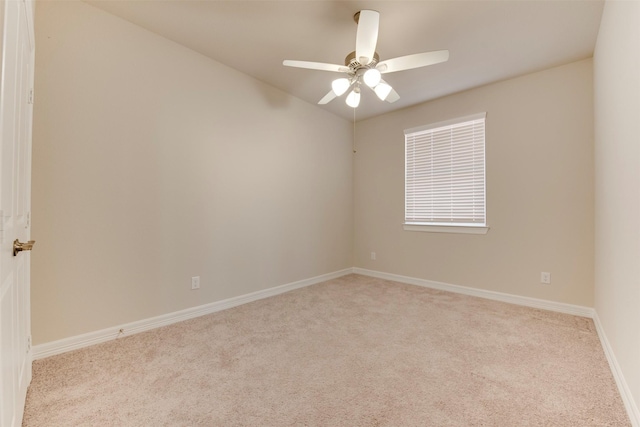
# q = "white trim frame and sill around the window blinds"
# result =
<box><xmin>403</xmin><ymin>112</ymin><xmax>489</xmax><ymax>234</ymax></box>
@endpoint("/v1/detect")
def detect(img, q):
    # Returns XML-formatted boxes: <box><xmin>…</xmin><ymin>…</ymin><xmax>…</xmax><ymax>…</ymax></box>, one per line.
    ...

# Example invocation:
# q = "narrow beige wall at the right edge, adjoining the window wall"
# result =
<box><xmin>594</xmin><ymin>1</ymin><xmax>640</xmax><ymax>416</ymax></box>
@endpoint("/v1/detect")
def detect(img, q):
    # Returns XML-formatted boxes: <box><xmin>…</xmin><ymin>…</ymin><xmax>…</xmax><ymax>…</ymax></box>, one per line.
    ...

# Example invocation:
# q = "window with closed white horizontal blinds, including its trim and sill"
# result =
<box><xmin>404</xmin><ymin>113</ymin><xmax>488</xmax><ymax>234</ymax></box>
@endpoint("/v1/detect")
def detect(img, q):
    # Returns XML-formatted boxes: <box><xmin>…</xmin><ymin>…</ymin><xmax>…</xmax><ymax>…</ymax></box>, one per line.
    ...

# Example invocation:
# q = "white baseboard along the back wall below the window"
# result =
<box><xmin>353</xmin><ymin>267</ymin><xmax>594</xmax><ymax>318</ymax></box>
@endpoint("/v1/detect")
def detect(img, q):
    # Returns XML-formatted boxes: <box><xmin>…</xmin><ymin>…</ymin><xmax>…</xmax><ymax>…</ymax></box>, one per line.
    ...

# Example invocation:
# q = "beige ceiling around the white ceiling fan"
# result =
<box><xmin>85</xmin><ymin>0</ymin><xmax>604</xmax><ymax>120</ymax></box>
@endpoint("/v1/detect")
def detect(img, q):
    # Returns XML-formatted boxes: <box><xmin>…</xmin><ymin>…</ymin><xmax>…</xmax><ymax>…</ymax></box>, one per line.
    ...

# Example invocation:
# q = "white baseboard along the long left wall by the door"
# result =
<box><xmin>32</xmin><ymin>268</ymin><xmax>353</xmax><ymax>360</ymax></box>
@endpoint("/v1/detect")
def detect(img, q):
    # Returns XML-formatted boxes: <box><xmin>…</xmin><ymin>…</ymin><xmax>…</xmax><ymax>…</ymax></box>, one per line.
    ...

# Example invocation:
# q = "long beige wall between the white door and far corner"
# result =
<box><xmin>32</xmin><ymin>2</ymin><xmax>353</xmax><ymax>344</ymax></box>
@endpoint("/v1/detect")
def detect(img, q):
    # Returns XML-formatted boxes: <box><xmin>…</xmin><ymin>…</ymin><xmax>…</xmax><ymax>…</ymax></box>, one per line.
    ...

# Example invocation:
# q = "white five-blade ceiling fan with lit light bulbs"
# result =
<box><xmin>282</xmin><ymin>10</ymin><xmax>449</xmax><ymax>108</ymax></box>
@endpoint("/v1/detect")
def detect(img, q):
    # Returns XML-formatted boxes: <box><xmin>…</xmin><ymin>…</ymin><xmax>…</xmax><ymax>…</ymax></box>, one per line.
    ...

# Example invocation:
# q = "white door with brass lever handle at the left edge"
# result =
<box><xmin>0</xmin><ymin>0</ymin><xmax>35</xmax><ymax>427</ymax></box>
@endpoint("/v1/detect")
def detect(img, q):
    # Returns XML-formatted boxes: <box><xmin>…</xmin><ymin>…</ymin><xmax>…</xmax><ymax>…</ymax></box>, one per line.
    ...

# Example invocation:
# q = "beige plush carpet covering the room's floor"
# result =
<box><xmin>23</xmin><ymin>275</ymin><xmax>630</xmax><ymax>427</ymax></box>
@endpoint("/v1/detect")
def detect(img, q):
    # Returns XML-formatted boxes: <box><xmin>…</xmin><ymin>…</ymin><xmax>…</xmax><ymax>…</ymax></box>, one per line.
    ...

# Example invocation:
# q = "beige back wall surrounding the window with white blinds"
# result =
<box><xmin>354</xmin><ymin>60</ymin><xmax>593</xmax><ymax>306</ymax></box>
